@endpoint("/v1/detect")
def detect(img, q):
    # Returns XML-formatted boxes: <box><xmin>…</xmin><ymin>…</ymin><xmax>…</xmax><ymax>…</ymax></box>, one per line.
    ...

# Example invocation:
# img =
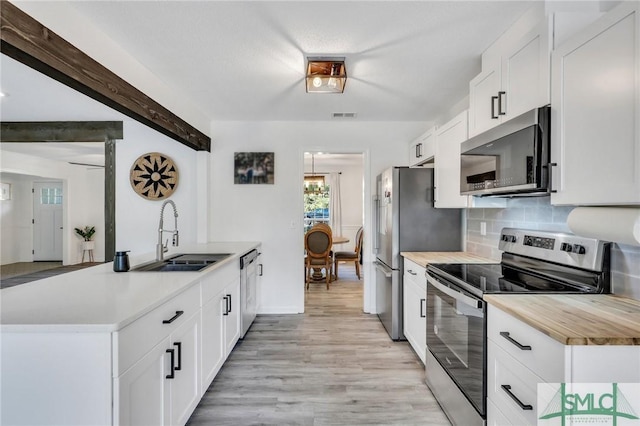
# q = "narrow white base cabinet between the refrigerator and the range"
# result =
<box><xmin>402</xmin><ymin>259</ymin><xmax>427</xmax><ymax>364</ymax></box>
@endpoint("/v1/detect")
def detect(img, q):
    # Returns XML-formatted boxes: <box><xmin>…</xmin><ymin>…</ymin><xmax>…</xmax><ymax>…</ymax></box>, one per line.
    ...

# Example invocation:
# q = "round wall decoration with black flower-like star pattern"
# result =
<box><xmin>130</xmin><ymin>152</ymin><xmax>178</xmax><ymax>200</ymax></box>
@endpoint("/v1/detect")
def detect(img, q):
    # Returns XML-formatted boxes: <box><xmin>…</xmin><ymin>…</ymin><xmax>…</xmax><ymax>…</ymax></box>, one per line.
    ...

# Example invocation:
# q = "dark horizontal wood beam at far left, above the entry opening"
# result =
<box><xmin>0</xmin><ymin>121</ymin><xmax>123</xmax><ymax>142</ymax></box>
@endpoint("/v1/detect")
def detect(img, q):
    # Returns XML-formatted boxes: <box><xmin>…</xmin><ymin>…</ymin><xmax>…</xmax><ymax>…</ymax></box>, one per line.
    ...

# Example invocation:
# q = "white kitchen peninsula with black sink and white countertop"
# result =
<box><xmin>0</xmin><ymin>242</ymin><xmax>260</xmax><ymax>425</ymax></box>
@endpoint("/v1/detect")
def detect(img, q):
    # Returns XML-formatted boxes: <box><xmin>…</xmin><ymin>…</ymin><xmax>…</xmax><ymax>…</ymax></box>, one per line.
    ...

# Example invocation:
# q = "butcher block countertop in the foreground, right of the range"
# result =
<box><xmin>484</xmin><ymin>294</ymin><xmax>640</xmax><ymax>346</ymax></box>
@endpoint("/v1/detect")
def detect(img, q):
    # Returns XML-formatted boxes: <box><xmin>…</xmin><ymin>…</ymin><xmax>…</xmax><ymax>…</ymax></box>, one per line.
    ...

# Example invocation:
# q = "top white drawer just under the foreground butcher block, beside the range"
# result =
<box><xmin>487</xmin><ymin>305</ymin><xmax>565</xmax><ymax>383</ymax></box>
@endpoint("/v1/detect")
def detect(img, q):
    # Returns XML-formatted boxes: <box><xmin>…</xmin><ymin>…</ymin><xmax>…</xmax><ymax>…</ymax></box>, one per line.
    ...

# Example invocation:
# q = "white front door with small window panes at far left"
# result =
<box><xmin>33</xmin><ymin>182</ymin><xmax>62</xmax><ymax>261</ymax></box>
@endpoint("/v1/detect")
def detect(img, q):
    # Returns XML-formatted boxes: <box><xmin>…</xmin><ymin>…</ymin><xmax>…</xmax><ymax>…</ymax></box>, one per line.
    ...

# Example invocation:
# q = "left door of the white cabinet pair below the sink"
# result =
<box><xmin>201</xmin><ymin>295</ymin><xmax>226</xmax><ymax>393</ymax></box>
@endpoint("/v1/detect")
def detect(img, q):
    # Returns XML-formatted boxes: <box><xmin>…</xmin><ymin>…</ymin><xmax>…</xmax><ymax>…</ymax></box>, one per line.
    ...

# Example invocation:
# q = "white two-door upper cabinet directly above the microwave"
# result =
<box><xmin>469</xmin><ymin>19</ymin><xmax>552</xmax><ymax>137</ymax></box>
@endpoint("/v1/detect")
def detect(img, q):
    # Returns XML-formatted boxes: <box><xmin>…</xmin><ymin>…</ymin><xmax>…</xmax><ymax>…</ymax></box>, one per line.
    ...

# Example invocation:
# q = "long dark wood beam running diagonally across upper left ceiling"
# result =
<box><xmin>0</xmin><ymin>0</ymin><xmax>211</xmax><ymax>151</ymax></box>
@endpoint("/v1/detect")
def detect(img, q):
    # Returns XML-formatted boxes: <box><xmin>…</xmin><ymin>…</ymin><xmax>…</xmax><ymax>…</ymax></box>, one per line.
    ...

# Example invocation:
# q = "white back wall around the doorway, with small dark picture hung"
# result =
<box><xmin>209</xmin><ymin>122</ymin><xmax>424</xmax><ymax>313</ymax></box>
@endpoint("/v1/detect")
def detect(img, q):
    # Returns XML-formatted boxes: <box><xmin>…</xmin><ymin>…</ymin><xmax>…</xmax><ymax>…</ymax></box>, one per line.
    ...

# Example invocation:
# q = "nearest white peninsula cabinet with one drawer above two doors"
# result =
<box><xmin>114</xmin><ymin>285</ymin><xmax>200</xmax><ymax>425</ymax></box>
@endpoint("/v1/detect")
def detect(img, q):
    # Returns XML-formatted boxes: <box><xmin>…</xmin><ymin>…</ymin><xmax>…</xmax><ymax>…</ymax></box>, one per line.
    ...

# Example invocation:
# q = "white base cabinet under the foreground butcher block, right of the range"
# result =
<box><xmin>487</xmin><ymin>304</ymin><xmax>640</xmax><ymax>426</ymax></box>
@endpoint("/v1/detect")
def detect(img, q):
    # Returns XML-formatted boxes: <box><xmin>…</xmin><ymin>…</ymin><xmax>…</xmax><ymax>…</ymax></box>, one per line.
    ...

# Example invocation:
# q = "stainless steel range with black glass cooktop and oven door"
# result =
<box><xmin>426</xmin><ymin>228</ymin><xmax>610</xmax><ymax>426</ymax></box>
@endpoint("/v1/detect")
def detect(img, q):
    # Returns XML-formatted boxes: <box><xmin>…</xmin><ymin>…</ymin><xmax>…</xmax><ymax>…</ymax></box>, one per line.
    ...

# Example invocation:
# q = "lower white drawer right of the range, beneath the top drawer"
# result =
<box><xmin>487</xmin><ymin>342</ymin><xmax>543</xmax><ymax>425</ymax></box>
